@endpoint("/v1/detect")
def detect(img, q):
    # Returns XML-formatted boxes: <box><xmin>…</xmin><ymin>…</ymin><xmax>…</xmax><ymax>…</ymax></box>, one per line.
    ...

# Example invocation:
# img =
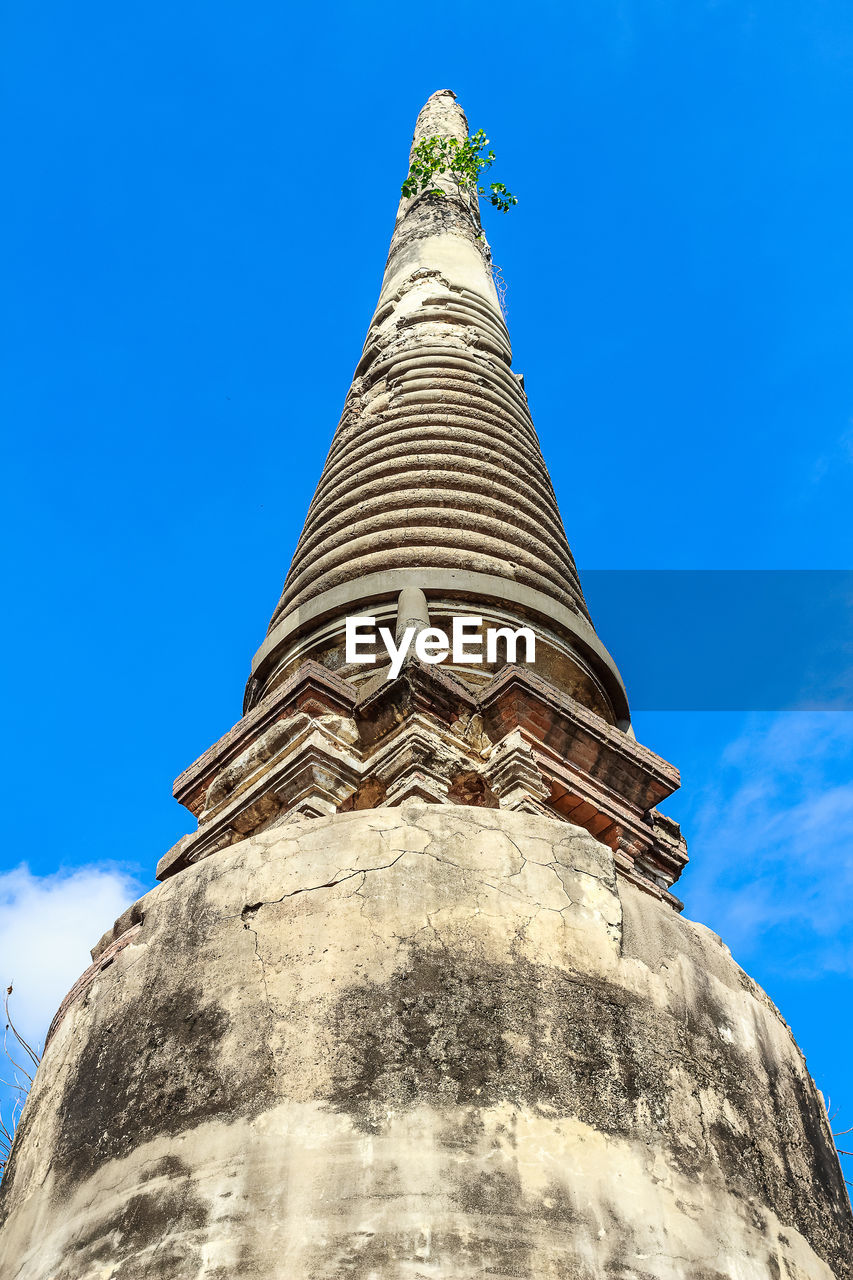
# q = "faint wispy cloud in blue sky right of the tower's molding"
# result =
<box><xmin>689</xmin><ymin>712</ymin><xmax>853</xmax><ymax>977</ymax></box>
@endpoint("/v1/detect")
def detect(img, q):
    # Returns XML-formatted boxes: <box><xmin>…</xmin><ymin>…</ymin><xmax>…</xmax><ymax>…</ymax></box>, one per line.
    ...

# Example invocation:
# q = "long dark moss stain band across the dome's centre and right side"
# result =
<box><xmin>327</xmin><ymin>946</ymin><xmax>853</xmax><ymax>1276</ymax></box>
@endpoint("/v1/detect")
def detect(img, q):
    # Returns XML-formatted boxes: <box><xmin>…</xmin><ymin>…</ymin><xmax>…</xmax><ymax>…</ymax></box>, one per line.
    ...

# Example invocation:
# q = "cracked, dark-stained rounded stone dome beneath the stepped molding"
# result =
<box><xmin>0</xmin><ymin>804</ymin><xmax>853</xmax><ymax>1280</ymax></box>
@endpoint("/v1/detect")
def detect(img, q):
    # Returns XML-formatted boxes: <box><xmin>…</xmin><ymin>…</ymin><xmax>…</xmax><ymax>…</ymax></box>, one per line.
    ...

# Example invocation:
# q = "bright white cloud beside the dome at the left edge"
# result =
<box><xmin>0</xmin><ymin>864</ymin><xmax>145</xmax><ymax>1042</ymax></box>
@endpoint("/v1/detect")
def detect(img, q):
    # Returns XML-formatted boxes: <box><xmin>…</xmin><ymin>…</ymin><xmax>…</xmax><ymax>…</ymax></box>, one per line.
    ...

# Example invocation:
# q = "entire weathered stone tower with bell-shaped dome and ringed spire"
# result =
<box><xmin>0</xmin><ymin>91</ymin><xmax>853</xmax><ymax>1280</ymax></box>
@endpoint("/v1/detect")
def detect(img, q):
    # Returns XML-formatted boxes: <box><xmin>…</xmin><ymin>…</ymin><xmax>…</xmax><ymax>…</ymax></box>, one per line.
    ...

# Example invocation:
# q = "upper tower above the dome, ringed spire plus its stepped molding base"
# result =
<box><xmin>166</xmin><ymin>90</ymin><xmax>686</xmax><ymax>905</ymax></box>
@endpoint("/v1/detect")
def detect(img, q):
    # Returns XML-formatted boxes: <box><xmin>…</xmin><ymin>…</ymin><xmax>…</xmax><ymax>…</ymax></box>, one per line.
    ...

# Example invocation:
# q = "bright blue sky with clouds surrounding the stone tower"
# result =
<box><xmin>0</xmin><ymin>0</ymin><xmax>853</xmax><ymax>1172</ymax></box>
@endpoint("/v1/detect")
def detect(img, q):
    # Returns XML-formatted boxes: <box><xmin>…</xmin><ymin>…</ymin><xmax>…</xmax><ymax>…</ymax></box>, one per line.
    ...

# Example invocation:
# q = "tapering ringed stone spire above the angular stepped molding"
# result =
<box><xmin>250</xmin><ymin>90</ymin><xmax>626</xmax><ymax>722</ymax></box>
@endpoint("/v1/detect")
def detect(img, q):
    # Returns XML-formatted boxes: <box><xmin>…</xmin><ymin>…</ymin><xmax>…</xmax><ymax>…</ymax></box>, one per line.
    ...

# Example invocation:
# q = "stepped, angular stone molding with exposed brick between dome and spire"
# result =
<box><xmin>158</xmin><ymin>658</ymin><xmax>686</xmax><ymax>909</ymax></box>
